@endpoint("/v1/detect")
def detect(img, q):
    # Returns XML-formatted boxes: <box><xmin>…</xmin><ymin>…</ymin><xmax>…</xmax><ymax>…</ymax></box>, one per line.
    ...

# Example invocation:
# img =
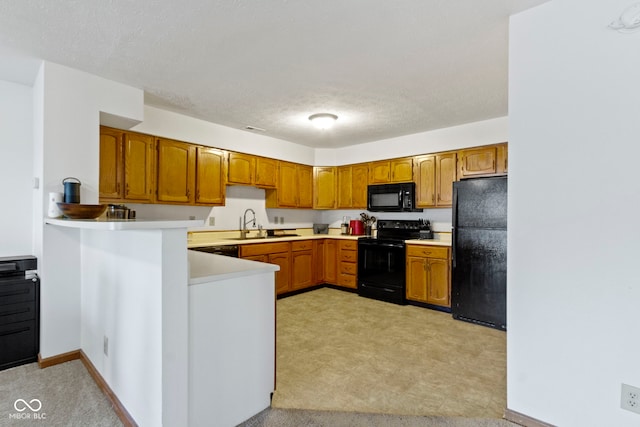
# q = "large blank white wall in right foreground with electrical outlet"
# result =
<box><xmin>507</xmin><ymin>0</ymin><xmax>640</xmax><ymax>427</ymax></box>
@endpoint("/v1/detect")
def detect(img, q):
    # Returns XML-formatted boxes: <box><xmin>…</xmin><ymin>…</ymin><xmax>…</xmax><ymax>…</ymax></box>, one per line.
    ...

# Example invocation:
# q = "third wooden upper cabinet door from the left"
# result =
<box><xmin>157</xmin><ymin>139</ymin><xmax>196</xmax><ymax>203</ymax></box>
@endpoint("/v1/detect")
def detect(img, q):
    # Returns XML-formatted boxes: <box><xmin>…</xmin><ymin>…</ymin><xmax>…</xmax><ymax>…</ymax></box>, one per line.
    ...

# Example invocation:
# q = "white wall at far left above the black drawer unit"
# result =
<box><xmin>0</xmin><ymin>81</ymin><xmax>35</xmax><ymax>257</ymax></box>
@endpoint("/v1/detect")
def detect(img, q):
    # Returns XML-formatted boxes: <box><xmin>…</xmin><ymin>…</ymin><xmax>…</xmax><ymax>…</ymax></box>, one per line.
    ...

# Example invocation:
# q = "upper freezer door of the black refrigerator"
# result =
<box><xmin>453</xmin><ymin>176</ymin><xmax>507</xmax><ymax>228</ymax></box>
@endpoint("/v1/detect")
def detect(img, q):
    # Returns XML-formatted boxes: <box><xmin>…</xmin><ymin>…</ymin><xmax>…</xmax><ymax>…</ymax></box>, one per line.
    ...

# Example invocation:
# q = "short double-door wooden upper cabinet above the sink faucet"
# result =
<box><xmin>227</xmin><ymin>151</ymin><xmax>278</xmax><ymax>188</ymax></box>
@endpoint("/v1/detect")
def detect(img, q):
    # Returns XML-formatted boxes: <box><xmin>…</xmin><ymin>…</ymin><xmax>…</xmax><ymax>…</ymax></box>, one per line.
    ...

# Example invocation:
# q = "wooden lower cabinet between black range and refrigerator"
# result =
<box><xmin>406</xmin><ymin>245</ymin><xmax>451</xmax><ymax>307</ymax></box>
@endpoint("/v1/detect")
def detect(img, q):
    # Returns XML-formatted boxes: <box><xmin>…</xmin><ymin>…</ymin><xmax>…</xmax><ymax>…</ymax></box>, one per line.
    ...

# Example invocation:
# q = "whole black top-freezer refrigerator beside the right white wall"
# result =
<box><xmin>451</xmin><ymin>176</ymin><xmax>507</xmax><ymax>330</ymax></box>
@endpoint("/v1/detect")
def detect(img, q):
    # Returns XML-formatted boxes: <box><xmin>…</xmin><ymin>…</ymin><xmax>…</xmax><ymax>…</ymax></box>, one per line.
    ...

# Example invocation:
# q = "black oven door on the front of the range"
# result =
<box><xmin>358</xmin><ymin>239</ymin><xmax>405</xmax><ymax>304</ymax></box>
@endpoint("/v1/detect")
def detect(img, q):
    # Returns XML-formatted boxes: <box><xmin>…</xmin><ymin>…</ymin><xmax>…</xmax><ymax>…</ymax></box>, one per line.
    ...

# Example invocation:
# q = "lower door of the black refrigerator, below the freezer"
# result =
<box><xmin>451</xmin><ymin>228</ymin><xmax>507</xmax><ymax>330</ymax></box>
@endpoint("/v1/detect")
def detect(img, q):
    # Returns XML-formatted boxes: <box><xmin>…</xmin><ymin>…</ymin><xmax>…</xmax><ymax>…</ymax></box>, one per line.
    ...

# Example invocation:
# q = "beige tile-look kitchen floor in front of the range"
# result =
<box><xmin>272</xmin><ymin>288</ymin><xmax>506</xmax><ymax>418</ymax></box>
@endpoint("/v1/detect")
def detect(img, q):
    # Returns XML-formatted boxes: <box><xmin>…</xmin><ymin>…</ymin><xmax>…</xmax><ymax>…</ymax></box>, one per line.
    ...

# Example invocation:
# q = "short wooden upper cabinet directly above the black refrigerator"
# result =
<box><xmin>458</xmin><ymin>143</ymin><xmax>507</xmax><ymax>179</ymax></box>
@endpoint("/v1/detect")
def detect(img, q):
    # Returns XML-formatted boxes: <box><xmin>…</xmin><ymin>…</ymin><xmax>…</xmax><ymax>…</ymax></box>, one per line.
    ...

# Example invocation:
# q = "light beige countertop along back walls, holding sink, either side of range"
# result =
<box><xmin>187</xmin><ymin>229</ymin><xmax>451</xmax><ymax>248</ymax></box>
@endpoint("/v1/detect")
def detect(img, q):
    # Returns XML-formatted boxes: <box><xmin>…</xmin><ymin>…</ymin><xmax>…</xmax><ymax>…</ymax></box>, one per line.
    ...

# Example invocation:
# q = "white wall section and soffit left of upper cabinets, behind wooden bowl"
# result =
<box><xmin>33</xmin><ymin>62</ymin><xmax>143</xmax><ymax>358</ymax></box>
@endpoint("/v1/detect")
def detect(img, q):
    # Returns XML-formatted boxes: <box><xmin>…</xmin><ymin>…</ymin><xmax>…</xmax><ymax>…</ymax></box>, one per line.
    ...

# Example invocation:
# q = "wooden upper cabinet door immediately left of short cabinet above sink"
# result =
<box><xmin>196</xmin><ymin>147</ymin><xmax>226</xmax><ymax>205</ymax></box>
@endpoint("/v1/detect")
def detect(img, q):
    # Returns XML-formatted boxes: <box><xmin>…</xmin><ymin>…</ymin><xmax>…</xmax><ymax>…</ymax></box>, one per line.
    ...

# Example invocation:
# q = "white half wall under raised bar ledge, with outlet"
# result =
<box><xmin>81</xmin><ymin>229</ymin><xmax>188</xmax><ymax>426</ymax></box>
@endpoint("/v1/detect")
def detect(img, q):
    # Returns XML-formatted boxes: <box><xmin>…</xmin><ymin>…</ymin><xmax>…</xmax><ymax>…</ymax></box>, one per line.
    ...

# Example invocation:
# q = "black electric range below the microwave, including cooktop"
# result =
<box><xmin>358</xmin><ymin>219</ymin><xmax>433</xmax><ymax>304</ymax></box>
